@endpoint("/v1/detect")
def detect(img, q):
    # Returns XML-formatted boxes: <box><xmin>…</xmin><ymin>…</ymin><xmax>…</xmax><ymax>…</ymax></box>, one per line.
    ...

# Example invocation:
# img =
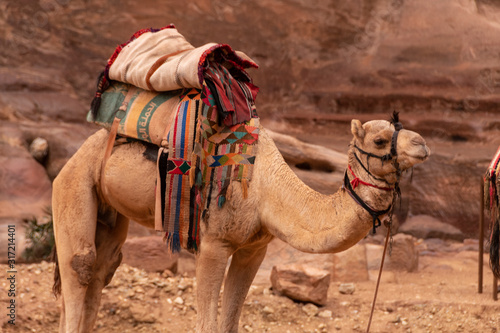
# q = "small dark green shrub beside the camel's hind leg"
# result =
<box><xmin>22</xmin><ymin>208</ymin><xmax>55</xmax><ymax>262</ymax></box>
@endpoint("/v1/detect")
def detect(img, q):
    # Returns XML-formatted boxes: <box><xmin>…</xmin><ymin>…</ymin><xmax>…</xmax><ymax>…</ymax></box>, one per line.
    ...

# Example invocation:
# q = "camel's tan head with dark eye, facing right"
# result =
<box><xmin>351</xmin><ymin>113</ymin><xmax>431</xmax><ymax>182</ymax></box>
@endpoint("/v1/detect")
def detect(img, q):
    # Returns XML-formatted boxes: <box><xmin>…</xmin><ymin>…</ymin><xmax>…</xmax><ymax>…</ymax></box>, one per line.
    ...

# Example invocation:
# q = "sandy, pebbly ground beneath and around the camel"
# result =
<box><xmin>0</xmin><ymin>237</ymin><xmax>500</xmax><ymax>333</ymax></box>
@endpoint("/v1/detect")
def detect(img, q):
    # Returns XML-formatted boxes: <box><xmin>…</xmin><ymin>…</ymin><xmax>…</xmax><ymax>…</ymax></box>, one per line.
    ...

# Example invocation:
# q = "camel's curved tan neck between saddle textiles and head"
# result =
<box><xmin>255</xmin><ymin>130</ymin><xmax>392</xmax><ymax>253</ymax></box>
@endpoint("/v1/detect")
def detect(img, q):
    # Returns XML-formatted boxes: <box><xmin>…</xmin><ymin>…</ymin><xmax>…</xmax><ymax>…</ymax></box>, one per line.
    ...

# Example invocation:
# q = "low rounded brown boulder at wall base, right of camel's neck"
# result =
<box><xmin>399</xmin><ymin>215</ymin><xmax>465</xmax><ymax>241</ymax></box>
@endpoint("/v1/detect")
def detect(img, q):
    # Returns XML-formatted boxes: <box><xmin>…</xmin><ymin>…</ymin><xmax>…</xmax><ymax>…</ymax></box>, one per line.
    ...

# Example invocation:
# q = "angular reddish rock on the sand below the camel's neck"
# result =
<box><xmin>271</xmin><ymin>264</ymin><xmax>330</xmax><ymax>305</ymax></box>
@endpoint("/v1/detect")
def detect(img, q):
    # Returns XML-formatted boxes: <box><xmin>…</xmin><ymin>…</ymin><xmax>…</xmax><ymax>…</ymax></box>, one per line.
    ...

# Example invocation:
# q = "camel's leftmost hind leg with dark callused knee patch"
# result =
<box><xmin>52</xmin><ymin>174</ymin><xmax>97</xmax><ymax>332</ymax></box>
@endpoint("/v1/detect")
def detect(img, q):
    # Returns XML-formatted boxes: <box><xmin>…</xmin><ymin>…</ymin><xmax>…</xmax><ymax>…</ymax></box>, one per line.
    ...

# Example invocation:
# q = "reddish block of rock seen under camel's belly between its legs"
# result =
<box><xmin>122</xmin><ymin>236</ymin><xmax>178</xmax><ymax>273</ymax></box>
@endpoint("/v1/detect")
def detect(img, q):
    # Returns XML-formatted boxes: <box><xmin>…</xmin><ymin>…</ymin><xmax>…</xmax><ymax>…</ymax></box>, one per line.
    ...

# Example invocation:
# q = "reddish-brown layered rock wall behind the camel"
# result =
<box><xmin>0</xmin><ymin>0</ymin><xmax>500</xmax><ymax>237</ymax></box>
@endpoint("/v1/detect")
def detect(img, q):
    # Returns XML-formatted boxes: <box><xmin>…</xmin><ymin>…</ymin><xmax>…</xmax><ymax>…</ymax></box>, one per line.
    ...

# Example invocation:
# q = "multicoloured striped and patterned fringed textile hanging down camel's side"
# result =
<box><xmin>156</xmin><ymin>89</ymin><xmax>259</xmax><ymax>252</ymax></box>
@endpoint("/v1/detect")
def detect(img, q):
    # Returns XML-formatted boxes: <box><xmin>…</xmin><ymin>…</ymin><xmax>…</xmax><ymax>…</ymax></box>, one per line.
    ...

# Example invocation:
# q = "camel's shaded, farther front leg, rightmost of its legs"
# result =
<box><xmin>221</xmin><ymin>244</ymin><xmax>267</xmax><ymax>333</ymax></box>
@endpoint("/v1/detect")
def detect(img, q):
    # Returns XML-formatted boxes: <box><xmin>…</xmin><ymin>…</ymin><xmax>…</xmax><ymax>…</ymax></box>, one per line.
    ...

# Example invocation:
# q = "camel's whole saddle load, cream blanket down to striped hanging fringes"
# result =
<box><xmin>87</xmin><ymin>25</ymin><xmax>259</xmax><ymax>252</ymax></box>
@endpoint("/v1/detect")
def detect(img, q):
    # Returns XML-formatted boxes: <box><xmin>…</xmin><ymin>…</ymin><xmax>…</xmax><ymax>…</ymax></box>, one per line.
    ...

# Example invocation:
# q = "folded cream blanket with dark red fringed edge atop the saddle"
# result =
<box><xmin>91</xmin><ymin>25</ymin><xmax>259</xmax><ymax>126</ymax></box>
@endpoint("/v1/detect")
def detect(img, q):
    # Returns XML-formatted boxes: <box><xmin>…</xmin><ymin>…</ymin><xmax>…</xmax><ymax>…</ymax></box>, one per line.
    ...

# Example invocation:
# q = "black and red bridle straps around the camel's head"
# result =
<box><xmin>342</xmin><ymin>111</ymin><xmax>403</xmax><ymax>234</ymax></box>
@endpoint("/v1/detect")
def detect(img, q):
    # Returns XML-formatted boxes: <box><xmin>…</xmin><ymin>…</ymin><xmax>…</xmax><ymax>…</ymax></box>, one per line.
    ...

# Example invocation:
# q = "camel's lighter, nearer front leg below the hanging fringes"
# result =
<box><xmin>196</xmin><ymin>236</ymin><xmax>232</xmax><ymax>333</ymax></box>
